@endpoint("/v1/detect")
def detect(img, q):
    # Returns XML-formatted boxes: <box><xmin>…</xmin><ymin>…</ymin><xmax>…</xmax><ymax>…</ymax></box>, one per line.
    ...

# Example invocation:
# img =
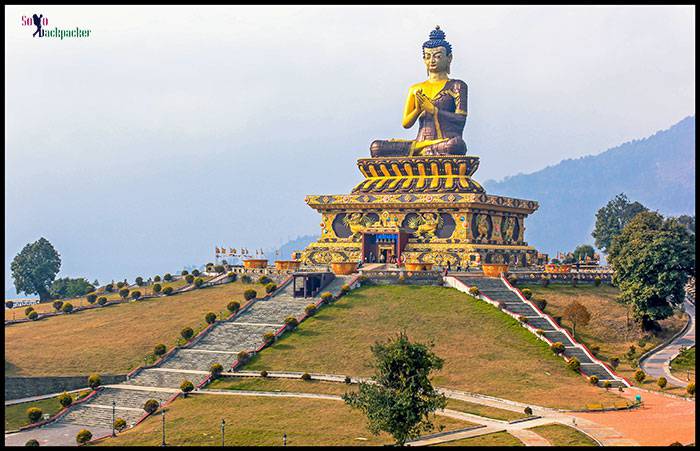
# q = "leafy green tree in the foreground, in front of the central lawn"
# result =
<box><xmin>343</xmin><ymin>332</ymin><xmax>447</xmax><ymax>445</ymax></box>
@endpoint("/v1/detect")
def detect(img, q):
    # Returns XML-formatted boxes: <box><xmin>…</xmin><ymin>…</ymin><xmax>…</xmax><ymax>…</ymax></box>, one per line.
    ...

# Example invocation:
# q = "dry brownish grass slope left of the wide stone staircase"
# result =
<box><xmin>5</xmin><ymin>282</ymin><xmax>264</xmax><ymax>376</ymax></box>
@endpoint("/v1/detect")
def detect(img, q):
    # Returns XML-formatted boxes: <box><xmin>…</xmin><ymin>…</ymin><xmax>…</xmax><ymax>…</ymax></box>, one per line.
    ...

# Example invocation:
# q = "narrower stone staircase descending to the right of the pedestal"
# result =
<box><xmin>456</xmin><ymin>276</ymin><xmax>626</xmax><ymax>387</ymax></box>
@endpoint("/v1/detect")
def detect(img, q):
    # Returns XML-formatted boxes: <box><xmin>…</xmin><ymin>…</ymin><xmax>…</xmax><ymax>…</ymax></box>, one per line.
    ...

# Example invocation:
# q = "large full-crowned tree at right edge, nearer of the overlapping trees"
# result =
<box><xmin>608</xmin><ymin>212</ymin><xmax>695</xmax><ymax>330</ymax></box>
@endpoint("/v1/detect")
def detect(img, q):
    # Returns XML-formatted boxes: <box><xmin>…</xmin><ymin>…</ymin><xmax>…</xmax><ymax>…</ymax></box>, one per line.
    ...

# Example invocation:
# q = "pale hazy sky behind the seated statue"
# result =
<box><xmin>5</xmin><ymin>6</ymin><xmax>695</xmax><ymax>296</ymax></box>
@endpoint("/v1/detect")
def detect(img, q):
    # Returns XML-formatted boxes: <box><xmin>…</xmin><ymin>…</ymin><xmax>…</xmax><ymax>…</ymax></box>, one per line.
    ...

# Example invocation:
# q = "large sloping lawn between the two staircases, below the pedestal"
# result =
<box><xmin>245</xmin><ymin>285</ymin><xmax>621</xmax><ymax>408</ymax></box>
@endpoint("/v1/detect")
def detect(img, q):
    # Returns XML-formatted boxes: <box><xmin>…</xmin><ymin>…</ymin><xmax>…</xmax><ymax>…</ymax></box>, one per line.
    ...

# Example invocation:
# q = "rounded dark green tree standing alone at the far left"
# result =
<box><xmin>10</xmin><ymin>238</ymin><xmax>61</xmax><ymax>302</ymax></box>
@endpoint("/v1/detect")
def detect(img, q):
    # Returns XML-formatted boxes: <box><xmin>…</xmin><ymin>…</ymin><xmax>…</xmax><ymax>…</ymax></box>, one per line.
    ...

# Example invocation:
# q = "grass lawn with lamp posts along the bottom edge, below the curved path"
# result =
<box><xmin>100</xmin><ymin>394</ymin><xmax>473</xmax><ymax>446</ymax></box>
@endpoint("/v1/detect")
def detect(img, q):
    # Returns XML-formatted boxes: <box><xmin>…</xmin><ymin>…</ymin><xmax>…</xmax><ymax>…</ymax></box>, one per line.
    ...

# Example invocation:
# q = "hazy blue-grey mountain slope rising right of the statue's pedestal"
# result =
<box><xmin>483</xmin><ymin>116</ymin><xmax>695</xmax><ymax>256</ymax></box>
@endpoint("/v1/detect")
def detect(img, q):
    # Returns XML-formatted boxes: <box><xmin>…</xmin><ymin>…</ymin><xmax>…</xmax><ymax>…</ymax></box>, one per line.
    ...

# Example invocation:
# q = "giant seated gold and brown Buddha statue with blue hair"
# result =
<box><xmin>370</xmin><ymin>26</ymin><xmax>467</xmax><ymax>157</ymax></box>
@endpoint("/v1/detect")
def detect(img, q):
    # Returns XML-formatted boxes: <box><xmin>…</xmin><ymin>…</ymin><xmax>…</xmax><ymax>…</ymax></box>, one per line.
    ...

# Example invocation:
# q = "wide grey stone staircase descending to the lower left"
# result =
<box><xmin>50</xmin><ymin>276</ymin><xmax>353</xmax><ymax>429</ymax></box>
